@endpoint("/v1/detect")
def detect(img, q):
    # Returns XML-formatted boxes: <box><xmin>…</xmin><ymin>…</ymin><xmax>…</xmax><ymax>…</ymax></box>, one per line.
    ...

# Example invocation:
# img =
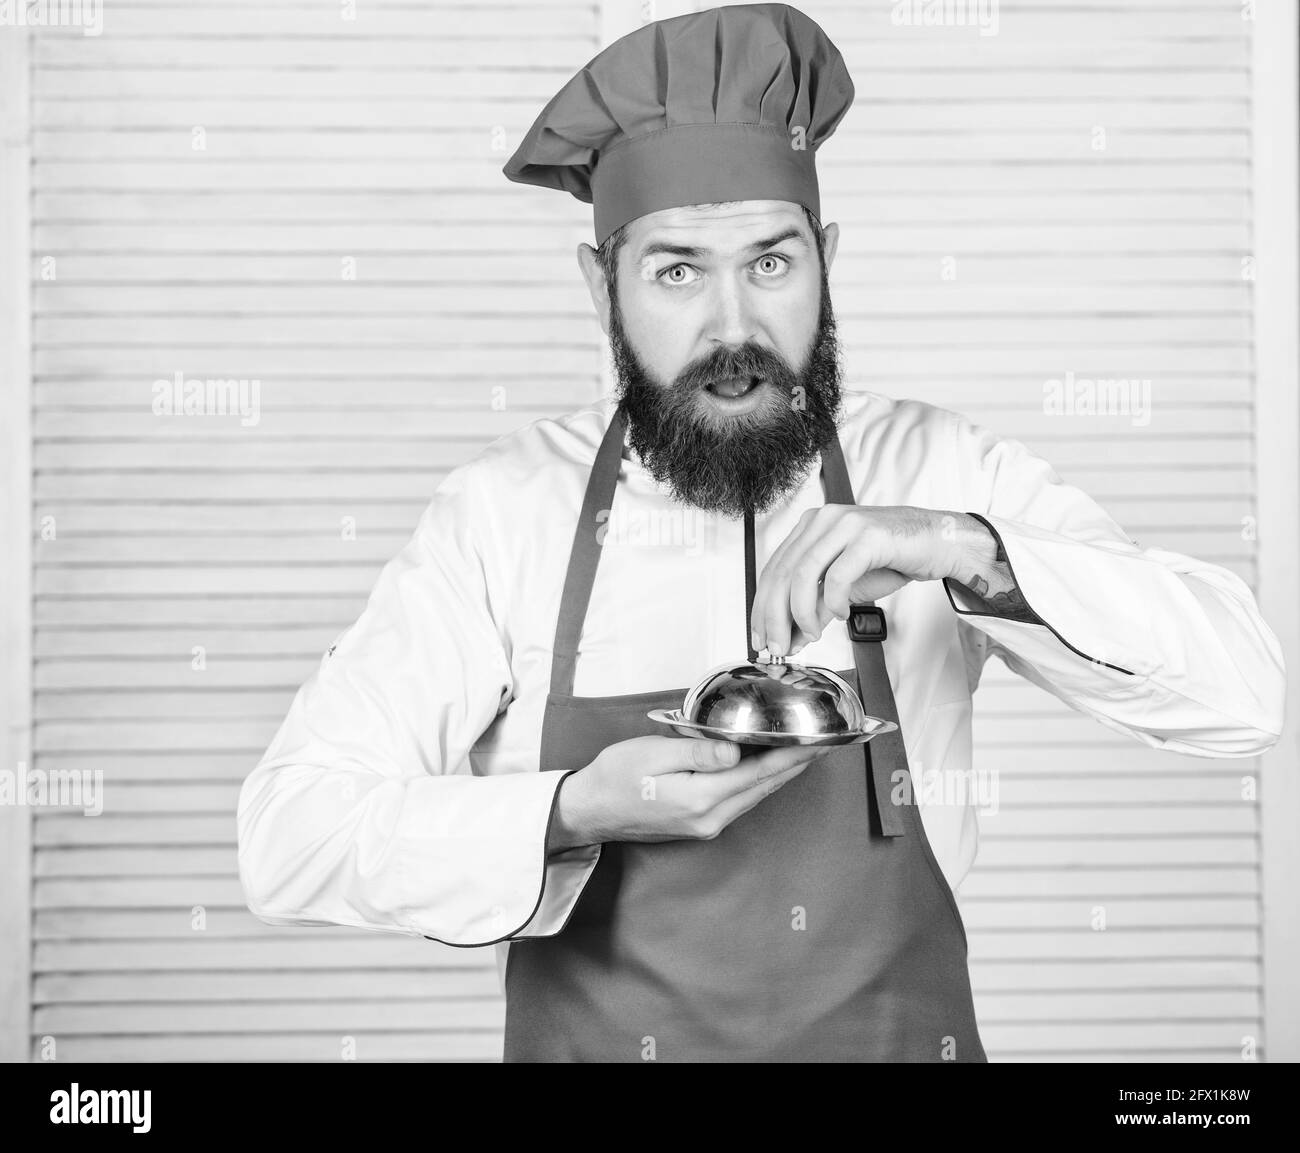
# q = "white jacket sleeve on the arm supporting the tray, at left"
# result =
<box><xmin>238</xmin><ymin>464</ymin><xmax>595</xmax><ymax>945</ymax></box>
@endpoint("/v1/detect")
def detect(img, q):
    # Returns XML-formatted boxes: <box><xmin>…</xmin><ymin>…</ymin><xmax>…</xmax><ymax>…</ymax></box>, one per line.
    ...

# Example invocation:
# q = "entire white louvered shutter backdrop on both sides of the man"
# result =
<box><xmin>33</xmin><ymin>0</ymin><xmax>1261</xmax><ymax>1061</ymax></box>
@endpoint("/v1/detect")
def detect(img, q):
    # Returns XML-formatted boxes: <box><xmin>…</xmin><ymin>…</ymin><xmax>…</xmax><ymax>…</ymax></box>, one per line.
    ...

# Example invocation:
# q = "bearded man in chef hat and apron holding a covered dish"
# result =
<box><xmin>239</xmin><ymin>4</ymin><xmax>1283</xmax><ymax>1062</ymax></box>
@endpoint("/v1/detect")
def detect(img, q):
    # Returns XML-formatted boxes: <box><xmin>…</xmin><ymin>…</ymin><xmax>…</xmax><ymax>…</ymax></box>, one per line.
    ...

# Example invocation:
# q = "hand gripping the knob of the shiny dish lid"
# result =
<box><xmin>750</xmin><ymin>504</ymin><xmax>997</xmax><ymax>656</ymax></box>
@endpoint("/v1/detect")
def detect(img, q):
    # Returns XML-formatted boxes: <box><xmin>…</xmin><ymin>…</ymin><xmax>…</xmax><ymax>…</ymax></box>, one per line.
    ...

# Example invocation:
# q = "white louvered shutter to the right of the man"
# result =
<box><xmin>805</xmin><ymin>0</ymin><xmax>1262</xmax><ymax>1061</ymax></box>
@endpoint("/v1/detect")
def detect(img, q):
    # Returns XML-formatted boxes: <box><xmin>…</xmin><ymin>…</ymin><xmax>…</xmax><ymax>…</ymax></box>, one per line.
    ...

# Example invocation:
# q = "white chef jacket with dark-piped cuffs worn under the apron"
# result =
<box><xmin>238</xmin><ymin>391</ymin><xmax>1284</xmax><ymax>982</ymax></box>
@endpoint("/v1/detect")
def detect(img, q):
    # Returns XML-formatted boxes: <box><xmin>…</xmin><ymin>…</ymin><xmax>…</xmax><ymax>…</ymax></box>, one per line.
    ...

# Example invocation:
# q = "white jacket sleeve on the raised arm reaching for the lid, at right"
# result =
<box><xmin>945</xmin><ymin>408</ymin><xmax>1286</xmax><ymax>757</ymax></box>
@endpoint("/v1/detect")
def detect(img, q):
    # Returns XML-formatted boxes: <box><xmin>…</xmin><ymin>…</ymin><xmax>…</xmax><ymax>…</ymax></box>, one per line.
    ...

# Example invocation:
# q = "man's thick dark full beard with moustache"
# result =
<box><xmin>610</xmin><ymin>274</ymin><xmax>841</xmax><ymax>517</ymax></box>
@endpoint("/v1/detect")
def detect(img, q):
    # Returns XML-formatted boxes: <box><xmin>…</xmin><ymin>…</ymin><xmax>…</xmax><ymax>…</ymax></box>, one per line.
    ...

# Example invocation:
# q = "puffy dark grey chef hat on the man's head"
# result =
<box><xmin>504</xmin><ymin>4</ymin><xmax>853</xmax><ymax>244</ymax></box>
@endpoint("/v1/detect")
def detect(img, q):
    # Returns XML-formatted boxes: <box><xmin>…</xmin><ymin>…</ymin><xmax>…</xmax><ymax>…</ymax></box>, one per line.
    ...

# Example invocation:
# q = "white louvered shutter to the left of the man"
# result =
<box><xmin>33</xmin><ymin>0</ymin><xmax>601</xmax><ymax>1061</ymax></box>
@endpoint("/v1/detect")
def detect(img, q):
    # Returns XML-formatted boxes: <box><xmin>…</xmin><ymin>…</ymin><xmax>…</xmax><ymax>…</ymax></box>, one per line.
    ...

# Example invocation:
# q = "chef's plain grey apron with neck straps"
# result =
<box><xmin>504</xmin><ymin>412</ymin><xmax>987</xmax><ymax>1062</ymax></box>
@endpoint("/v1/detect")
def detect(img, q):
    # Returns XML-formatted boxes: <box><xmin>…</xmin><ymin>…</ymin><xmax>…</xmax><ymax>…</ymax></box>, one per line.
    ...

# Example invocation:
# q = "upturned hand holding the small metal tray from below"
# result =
<box><xmin>546</xmin><ymin>737</ymin><xmax>829</xmax><ymax>853</ymax></box>
